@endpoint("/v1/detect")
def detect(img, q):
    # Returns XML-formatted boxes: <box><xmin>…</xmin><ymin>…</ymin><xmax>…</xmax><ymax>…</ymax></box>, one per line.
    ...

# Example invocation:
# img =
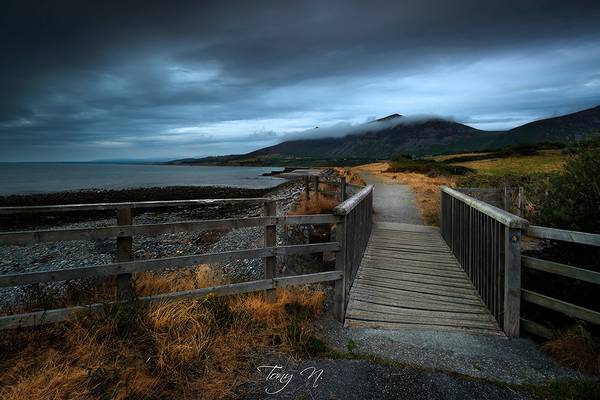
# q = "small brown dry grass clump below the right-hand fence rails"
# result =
<box><xmin>541</xmin><ymin>325</ymin><xmax>600</xmax><ymax>376</ymax></box>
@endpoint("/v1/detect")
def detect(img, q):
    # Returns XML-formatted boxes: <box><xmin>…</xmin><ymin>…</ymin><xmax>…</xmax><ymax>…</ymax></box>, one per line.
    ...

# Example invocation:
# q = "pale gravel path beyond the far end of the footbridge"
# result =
<box><xmin>360</xmin><ymin>173</ymin><xmax>423</xmax><ymax>225</ymax></box>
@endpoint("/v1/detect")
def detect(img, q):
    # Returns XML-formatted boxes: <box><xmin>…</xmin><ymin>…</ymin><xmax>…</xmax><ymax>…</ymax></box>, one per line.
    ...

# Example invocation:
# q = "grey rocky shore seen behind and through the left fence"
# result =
<box><xmin>0</xmin><ymin>181</ymin><xmax>328</xmax><ymax>305</ymax></box>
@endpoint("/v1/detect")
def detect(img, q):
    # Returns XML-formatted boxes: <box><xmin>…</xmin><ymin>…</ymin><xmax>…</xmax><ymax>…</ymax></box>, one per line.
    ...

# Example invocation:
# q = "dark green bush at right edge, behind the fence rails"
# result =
<box><xmin>537</xmin><ymin>147</ymin><xmax>600</xmax><ymax>233</ymax></box>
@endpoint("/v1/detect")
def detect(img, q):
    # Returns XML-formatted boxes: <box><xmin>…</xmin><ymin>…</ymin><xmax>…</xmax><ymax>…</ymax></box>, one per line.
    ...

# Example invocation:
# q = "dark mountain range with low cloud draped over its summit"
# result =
<box><xmin>172</xmin><ymin>106</ymin><xmax>600</xmax><ymax>165</ymax></box>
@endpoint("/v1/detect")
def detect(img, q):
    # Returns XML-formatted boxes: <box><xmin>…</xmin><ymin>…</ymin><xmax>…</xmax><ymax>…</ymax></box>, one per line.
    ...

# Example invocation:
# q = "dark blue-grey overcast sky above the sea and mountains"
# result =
<box><xmin>0</xmin><ymin>0</ymin><xmax>600</xmax><ymax>161</ymax></box>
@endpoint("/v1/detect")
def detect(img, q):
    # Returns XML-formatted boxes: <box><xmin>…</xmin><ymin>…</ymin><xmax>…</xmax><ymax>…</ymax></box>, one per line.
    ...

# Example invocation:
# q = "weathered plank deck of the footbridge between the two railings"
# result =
<box><xmin>346</xmin><ymin>222</ymin><xmax>502</xmax><ymax>335</ymax></box>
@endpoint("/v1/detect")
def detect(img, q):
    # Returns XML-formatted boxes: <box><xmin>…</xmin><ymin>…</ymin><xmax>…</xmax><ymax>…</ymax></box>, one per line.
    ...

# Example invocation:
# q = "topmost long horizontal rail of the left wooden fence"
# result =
<box><xmin>0</xmin><ymin>197</ymin><xmax>271</xmax><ymax>215</ymax></box>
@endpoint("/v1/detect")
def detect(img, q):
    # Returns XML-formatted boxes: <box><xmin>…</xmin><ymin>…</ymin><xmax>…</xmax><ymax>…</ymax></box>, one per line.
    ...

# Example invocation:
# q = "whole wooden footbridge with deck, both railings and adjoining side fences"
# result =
<box><xmin>0</xmin><ymin>178</ymin><xmax>600</xmax><ymax>336</ymax></box>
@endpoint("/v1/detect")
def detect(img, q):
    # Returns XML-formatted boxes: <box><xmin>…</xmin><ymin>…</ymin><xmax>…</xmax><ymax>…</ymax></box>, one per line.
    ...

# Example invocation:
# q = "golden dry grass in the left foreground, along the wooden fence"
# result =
<box><xmin>0</xmin><ymin>266</ymin><xmax>325</xmax><ymax>400</ymax></box>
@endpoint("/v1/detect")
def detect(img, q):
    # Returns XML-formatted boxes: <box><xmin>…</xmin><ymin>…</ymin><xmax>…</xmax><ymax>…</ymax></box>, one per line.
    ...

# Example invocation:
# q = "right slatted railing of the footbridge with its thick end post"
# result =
<box><xmin>440</xmin><ymin>187</ymin><xmax>528</xmax><ymax>336</ymax></box>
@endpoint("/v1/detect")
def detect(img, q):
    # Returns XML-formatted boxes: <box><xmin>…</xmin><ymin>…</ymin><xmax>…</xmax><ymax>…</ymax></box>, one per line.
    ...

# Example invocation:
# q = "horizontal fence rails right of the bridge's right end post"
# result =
<box><xmin>521</xmin><ymin>225</ymin><xmax>600</xmax><ymax>338</ymax></box>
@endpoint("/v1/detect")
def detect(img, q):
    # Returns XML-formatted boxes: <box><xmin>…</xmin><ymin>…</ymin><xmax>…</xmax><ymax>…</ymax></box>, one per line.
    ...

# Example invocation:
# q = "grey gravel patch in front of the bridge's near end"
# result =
<box><xmin>317</xmin><ymin>316</ymin><xmax>581</xmax><ymax>384</ymax></box>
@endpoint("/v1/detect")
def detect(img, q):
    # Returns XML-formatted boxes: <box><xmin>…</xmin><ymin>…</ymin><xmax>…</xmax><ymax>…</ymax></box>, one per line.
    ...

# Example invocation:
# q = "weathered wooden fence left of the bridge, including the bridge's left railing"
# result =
<box><xmin>0</xmin><ymin>180</ymin><xmax>372</xmax><ymax>329</ymax></box>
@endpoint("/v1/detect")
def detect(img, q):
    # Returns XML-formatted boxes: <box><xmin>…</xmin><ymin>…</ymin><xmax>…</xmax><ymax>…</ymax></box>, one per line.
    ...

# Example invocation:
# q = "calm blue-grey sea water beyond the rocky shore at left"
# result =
<box><xmin>0</xmin><ymin>163</ymin><xmax>284</xmax><ymax>195</ymax></box>
